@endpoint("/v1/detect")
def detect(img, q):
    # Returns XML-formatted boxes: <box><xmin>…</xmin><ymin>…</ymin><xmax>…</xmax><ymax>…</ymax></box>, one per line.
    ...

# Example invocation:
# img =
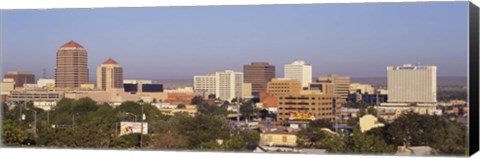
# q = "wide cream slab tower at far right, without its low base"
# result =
<box><xmin>387</xmin><ymin>64</ymin><xmax>437</xmax><ymax>104</ymax></box>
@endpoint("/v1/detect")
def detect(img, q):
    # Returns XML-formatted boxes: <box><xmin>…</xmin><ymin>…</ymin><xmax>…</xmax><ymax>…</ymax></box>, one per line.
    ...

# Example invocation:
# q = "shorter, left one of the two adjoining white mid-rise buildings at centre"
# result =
<box><xmin>193</xmin><ymin>74</ymin><xmax>217</xmax><ymax>97</ymax></box>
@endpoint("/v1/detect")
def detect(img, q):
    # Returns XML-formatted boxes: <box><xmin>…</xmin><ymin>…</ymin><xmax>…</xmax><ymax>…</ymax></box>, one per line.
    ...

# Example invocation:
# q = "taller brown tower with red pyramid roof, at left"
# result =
<box><xmin>55</xmin><ymin>41</ymin><xmax>88</xmax><ymax>89</ymax></box>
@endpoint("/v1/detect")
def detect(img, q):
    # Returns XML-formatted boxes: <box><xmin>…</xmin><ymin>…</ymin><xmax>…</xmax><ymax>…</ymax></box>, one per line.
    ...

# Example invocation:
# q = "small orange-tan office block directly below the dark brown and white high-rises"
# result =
<box><xmin>267</xmin><ymin>78</ymin><xmax>302</xmax><ymax>97</ymax></box>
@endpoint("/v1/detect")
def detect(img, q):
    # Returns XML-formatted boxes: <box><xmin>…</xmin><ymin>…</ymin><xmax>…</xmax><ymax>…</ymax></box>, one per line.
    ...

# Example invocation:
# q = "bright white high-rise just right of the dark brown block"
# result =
<box><xmin>284</xmin><ymin>61</ymin><xmax>312</xmax><ymax>87</ymax></box>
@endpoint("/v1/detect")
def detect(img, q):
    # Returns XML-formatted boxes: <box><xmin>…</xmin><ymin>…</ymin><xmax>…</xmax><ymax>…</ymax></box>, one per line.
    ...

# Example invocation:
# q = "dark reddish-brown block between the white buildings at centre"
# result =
<box><xmin>243</xmin><ymin>62</ymin><xmax>275</xmax><ymax>93</ymax></box>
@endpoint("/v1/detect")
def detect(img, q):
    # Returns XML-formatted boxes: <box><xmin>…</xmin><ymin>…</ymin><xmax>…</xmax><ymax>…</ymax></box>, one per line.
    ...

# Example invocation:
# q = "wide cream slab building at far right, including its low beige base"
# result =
<box><xmin>377</xmin><ymin>64</ymin><xmax>442</xmax><ymax>121</ymax></box>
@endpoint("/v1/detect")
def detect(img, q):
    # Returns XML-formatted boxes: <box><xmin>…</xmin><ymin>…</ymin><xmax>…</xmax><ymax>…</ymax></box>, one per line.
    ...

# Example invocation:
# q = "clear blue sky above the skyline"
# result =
<box><xmin>1</xmin><ymin>2</ymin><xmax>468</xmax><ymax>79</ymax></box>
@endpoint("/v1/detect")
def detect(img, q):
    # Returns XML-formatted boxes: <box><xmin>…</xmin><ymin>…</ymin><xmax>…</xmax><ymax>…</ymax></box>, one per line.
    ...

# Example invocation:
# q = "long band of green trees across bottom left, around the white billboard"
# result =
<box><xmin>2</xmin><ymin>98</ymin><xmax>260</xmax><ymax>151</ymax></box>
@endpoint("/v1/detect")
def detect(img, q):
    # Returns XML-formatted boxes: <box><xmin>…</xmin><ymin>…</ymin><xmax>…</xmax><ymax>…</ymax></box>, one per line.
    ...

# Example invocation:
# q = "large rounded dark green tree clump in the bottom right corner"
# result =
<box><xmin>386</xmin><ymin>112</ymin><xmax>466</xmax><ymax>155</ymax></box>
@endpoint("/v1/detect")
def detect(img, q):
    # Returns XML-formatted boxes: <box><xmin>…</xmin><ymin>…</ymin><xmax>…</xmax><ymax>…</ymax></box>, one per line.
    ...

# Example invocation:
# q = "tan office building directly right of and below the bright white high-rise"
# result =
<box><xmin>317</xmin><ymin>74</ymin><xmax>350</xmax><ymax>101</ymax></box>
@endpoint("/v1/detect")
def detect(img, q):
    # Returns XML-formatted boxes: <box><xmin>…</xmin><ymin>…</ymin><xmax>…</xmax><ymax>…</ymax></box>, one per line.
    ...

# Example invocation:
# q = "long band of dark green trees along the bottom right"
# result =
<box><xmin>297</xmin><ymin>112</ymin><xmax>467</xmax><ymax>155</ymax></box>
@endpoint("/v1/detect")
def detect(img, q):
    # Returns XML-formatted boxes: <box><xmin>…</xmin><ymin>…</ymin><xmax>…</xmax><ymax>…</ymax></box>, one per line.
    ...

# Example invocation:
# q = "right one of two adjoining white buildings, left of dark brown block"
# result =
<box><xmin>215</xmin><ymin>70</ymin><xmax>243</xmax><ymax>100</ymax></box>
